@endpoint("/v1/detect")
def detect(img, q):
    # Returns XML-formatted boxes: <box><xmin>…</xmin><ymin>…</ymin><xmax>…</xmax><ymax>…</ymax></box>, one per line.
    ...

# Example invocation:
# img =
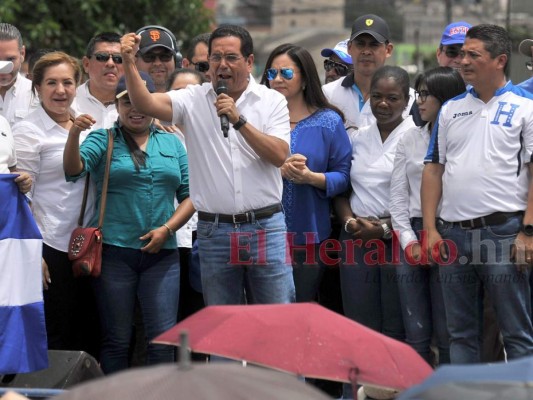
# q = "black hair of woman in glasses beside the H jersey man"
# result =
<box><xmin>415</xmin><ymin>67</ymin><xmax>466</xmax><ymax>105</ymax></box>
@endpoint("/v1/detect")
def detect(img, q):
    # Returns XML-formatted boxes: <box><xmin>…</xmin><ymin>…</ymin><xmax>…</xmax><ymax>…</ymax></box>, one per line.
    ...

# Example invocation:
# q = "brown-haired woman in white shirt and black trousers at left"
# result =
<box><xmin>13</xmin><ymin>52</ymin><xmax>99</xmax><ymax>356</ymax></box>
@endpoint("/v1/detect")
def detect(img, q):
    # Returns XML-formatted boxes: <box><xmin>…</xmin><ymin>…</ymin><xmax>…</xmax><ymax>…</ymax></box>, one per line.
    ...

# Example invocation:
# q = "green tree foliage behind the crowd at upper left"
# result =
<box><xmin>0</xmin><ymin>0</ymin><xmax>214</xmax><ymax>57</ymax></box>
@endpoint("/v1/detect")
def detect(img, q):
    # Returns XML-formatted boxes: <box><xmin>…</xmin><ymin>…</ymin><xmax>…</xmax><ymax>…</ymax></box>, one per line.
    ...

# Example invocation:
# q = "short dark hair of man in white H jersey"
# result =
<box><xmin>466</xmin><ymin>24</ymin><xmax>512</xmax><ymax>75</ymax></box>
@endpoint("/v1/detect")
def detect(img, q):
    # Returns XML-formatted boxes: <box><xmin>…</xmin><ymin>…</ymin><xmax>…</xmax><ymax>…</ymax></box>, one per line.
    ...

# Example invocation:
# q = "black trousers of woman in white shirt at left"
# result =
<box><xmin>43</xmin><ymin>244</ymin><xmax>100</xmax><ymax>358</ymax></box>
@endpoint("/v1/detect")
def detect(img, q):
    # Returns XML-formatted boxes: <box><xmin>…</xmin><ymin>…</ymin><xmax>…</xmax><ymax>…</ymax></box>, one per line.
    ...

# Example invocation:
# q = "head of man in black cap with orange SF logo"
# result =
<box><xmin>135</xmin><ymin>25</ymin><xmax>181</xmax><ymax>93</ymax></box>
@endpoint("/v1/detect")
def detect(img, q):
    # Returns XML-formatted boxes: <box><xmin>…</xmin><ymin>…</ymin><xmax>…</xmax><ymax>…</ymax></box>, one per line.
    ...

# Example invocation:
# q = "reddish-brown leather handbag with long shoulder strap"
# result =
<box><xmin>68</xmin><ymin>129</ymin><xmax>113</xmax><ymax>277</ymax></box>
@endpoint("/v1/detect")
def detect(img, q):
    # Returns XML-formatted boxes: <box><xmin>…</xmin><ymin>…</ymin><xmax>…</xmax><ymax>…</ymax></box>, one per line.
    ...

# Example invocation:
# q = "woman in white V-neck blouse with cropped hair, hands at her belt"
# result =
<box><xmin>335</xmin><ymin>66</ymin><xmax>415</xmax><ymax>340</ymax></box>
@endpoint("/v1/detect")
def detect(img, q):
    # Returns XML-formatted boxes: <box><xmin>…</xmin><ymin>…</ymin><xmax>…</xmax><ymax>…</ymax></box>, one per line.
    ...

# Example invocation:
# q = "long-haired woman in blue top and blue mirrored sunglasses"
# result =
<box><xmin>261</xmin><ymin>44</ymin><xmax>351</xmax><ymax>301</ymax></box>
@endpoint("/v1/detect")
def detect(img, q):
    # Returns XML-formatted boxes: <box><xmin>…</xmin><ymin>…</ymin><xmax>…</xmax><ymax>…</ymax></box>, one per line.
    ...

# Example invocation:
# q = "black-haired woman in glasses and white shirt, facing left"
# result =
<box><xmin>390</xmin><ymin>67</ymin><xmax>466</xmax><ymax>364</ymax></box>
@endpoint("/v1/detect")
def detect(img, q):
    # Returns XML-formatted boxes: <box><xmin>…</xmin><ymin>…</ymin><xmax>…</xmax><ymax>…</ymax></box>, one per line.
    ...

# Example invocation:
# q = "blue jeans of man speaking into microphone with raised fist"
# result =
<box><xmin>197</xmin><ymin>212</ymin><xmax>295</xmax><ymax>305</ymax></box>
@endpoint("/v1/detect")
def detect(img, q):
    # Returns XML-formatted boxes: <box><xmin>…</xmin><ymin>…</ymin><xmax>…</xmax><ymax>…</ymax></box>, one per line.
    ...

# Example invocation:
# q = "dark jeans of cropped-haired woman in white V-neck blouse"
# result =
<box><xmin>340</xmin><ymin>230</ymin><xmax>405</xmax><ymax>341</ymax></box>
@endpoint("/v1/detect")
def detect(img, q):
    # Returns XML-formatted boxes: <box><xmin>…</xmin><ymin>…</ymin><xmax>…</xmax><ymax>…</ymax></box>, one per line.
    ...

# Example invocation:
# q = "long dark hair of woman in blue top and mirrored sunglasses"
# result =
<box><xmin>261</xmin><ymin>43</ymin><xmax>344</xmax><ymax>121</ymax></box>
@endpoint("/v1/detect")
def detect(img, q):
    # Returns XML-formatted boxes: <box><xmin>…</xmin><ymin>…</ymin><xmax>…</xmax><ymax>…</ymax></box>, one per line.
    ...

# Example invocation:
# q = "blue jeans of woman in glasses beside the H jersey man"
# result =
<box><xmin>398</xmin><ymin>218</ymin><xmax>450</xmax><ymax>364</ymax></box>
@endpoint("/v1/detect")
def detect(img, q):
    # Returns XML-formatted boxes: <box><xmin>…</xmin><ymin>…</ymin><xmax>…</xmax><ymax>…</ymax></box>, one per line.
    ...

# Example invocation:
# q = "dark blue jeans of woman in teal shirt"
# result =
<box><xmin>94</xmin><ymin>245</ymin><xmax>180</xmax><ymax>374</ymax></box>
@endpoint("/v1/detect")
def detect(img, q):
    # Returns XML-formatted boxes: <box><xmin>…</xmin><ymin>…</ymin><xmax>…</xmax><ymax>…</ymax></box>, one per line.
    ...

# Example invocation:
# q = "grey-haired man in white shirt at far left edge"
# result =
<box><xmin>0</xmin><ymin>23</ymin><xmax>39</xmax><ymax>126</ymax></box>
